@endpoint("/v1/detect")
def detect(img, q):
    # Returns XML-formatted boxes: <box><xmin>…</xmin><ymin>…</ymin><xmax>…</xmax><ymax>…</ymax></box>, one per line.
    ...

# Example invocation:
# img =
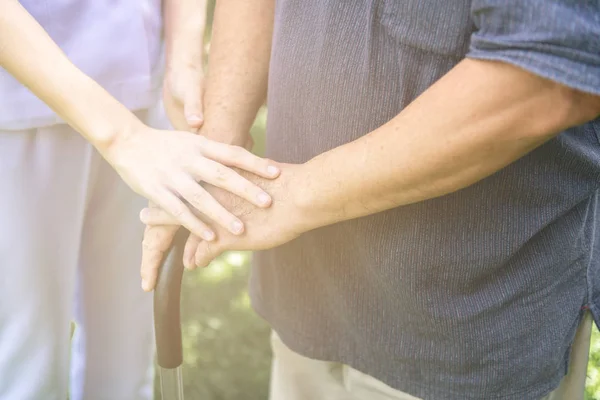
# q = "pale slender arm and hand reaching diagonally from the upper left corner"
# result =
<box><xmin>0</xmin><ymin>0</ymin><xmax>277</xmax><ymax>240</ymax></box>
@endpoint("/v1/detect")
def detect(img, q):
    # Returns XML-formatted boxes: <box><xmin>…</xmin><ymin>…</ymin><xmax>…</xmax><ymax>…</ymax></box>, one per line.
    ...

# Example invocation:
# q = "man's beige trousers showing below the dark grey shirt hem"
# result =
<box><xmin>270</xmin><ymin>313</ymin><xmax>592</xmax><ymax>400</ymax></box>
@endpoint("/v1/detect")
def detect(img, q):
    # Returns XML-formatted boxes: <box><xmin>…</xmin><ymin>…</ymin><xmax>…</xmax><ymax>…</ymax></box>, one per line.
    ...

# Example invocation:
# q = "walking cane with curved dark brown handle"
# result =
<box><xmin>154</xmin><ymin>228</ymin><xmax>189</xmax><ymax>400</ymax></box>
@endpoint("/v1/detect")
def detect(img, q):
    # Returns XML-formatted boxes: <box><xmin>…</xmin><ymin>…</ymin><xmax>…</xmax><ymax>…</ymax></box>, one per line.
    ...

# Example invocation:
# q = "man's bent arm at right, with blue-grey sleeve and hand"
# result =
<box><xmin>136</xmin><ymin>0</ymin><xmax>600</xmax><ymax>282</ymax></box>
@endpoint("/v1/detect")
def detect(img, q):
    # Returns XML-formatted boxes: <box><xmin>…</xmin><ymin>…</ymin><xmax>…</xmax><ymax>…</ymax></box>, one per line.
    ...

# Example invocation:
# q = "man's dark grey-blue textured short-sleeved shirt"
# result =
<box><xmin>250</xmin><ymin>0</ymin><xmax>600</xmax><ymax>400</ymax></box>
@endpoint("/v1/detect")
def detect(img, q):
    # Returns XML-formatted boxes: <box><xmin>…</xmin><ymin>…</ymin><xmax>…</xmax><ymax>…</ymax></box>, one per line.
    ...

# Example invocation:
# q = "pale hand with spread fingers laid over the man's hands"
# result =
<box><xmin>103</xmin><ymin>123</ymin><xmax>279</xmax><ymax>241</ymax></box>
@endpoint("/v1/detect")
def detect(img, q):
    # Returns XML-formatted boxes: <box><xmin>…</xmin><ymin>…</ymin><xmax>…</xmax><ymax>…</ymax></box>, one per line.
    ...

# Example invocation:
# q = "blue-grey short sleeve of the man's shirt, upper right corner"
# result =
<box><xmin>467</xmin><ymin>0</ymin><xmax>600</xmax><ymax>95</ymax></box>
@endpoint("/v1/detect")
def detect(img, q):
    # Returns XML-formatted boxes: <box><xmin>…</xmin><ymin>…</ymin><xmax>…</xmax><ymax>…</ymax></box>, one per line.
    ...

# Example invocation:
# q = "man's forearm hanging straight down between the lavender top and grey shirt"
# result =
<box><xmin>202</xmin><ymin>0</ymin><xmax>275</xmax><ymax>145</ymax></box>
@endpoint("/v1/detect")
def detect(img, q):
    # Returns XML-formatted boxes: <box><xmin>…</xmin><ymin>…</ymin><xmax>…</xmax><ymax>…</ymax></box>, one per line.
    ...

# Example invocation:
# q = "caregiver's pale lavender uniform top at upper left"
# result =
<box><xmin>0</xmin><ymin>0</ymin><xmax>162</xmax><ymax>130</ymax></box>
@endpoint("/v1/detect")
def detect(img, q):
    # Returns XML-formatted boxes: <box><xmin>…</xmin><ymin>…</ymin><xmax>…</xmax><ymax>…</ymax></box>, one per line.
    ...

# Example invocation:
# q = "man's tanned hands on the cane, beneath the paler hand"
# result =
<box><xmin>140</xmin><ymin>164</ymin><xmax>308</xmax><ymax>291</ymax></box>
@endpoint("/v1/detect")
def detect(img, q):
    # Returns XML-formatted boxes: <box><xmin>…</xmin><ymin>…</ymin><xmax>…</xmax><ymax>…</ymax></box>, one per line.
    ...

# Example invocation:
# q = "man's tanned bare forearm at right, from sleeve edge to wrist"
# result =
<box><xmin>295</xmin><ymin>60</ymin><xmax>600</xmax><ymax>229</ymax></box>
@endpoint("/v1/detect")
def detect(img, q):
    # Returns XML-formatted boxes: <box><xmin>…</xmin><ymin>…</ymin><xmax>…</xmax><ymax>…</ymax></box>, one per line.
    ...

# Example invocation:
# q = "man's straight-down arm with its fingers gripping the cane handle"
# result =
<box><xmin>141</xmin><ymin>0</ymin><xmax>275</xmax><ymax>290</ymax></box>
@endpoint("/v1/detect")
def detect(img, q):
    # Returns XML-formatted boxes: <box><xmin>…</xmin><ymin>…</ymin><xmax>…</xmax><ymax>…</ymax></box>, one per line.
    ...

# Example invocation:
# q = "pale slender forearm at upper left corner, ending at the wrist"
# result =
<box><xmin>0</xmin><ymin>0</ymin><xmax>141</xmax><ymax>151</ymax></box>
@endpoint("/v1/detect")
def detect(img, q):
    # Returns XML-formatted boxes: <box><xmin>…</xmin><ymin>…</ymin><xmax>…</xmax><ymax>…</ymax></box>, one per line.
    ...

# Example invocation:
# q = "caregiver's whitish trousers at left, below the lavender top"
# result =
<box><xmin>0</xmin><ymin>112</ymin><xmax>154</xmax><ymax>400</ymax></box>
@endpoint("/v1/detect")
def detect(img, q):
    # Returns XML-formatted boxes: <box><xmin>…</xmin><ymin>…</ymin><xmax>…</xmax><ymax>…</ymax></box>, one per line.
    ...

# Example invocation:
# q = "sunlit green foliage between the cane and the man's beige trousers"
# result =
<box><xmin>172</xmin><ymin>252</ymin><xmax>271</xmax><ymax>400</ymax></box>
